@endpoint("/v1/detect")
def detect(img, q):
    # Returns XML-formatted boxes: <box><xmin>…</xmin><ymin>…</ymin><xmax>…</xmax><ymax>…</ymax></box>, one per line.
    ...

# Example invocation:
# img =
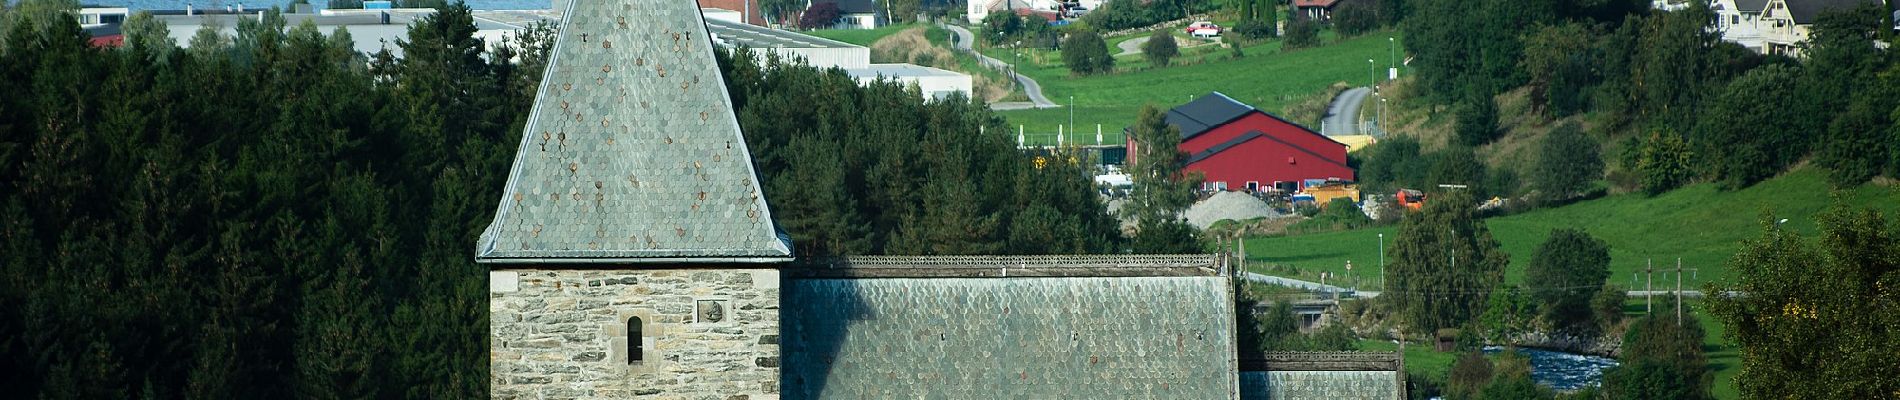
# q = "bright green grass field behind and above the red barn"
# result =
<box><xmin>984</xmin><ymin>30</ymin><xmax>1400</xmax><ymax>132</ymax></box>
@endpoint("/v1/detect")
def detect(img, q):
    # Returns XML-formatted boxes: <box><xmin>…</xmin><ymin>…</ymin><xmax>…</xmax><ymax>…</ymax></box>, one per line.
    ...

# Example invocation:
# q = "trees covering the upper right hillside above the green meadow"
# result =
<box><xmin>1362</xmin><ymin>0</ymin><xmax>1900</xmax><ymax>201</ymax></box>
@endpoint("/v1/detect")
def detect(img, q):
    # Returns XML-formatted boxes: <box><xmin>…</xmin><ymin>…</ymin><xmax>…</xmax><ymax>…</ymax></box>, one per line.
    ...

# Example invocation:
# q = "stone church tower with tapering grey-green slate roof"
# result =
<box><xmin>475</xmin><ymin>0</ymin><xmax>792</xmax><ymax>400</ymax></box>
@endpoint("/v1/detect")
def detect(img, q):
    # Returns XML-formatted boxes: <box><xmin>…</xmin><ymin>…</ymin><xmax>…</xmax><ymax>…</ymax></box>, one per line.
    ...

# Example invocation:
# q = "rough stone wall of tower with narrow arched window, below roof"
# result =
<box><xmin>488</xmin><ymin>269</ymin><xmax>779</xmax><ymax>400</ymax></box>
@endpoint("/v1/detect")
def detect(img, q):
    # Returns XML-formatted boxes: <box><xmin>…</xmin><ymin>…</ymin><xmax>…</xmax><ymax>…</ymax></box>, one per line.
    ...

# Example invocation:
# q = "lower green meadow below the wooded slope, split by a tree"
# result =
<box><xmin>1246</xmin><ymin>169</ymin><xmax>1900</xmax><ymax>288</ymax></box>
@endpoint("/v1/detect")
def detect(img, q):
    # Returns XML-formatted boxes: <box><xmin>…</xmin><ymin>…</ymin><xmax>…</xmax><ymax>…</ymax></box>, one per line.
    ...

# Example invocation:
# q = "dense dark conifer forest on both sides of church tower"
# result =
<box><xmin>0</xmin><ymin>0</ymin><xmax>1125</xmax><ymax>398</ymax></box>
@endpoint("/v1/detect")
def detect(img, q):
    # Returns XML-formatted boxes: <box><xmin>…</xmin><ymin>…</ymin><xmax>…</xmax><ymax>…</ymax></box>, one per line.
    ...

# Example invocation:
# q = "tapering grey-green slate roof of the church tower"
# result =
<box><xmin>475</xmin><ymin>0</ymin><xmax>792</xmax><ymax>264</ymax></box>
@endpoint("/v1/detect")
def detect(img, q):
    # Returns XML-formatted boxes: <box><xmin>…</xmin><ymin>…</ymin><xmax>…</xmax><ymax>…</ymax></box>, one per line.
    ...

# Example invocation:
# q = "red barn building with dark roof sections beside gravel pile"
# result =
<box><xmin>1129</xmin><ymin>91</ymin><xmax>1353</xmax><ymax>190</ymax></box>
